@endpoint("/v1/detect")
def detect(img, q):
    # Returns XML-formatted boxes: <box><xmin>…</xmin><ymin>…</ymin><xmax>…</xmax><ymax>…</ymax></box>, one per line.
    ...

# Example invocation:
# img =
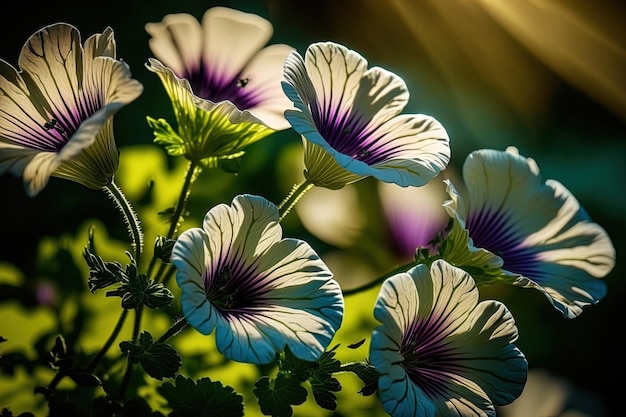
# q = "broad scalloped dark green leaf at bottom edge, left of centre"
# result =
<box><xmin>157</xmin><ymin>375</ymin><xmax>243</xmax><ymax>417</ymax></box>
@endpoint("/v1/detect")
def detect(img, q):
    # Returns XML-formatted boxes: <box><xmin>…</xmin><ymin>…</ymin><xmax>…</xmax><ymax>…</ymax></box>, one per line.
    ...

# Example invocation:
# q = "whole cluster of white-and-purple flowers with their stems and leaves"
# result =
<box><xmin>0</xmin><ymin>7</ymin><xmax>616</xmax><ymax>417</ymax></box>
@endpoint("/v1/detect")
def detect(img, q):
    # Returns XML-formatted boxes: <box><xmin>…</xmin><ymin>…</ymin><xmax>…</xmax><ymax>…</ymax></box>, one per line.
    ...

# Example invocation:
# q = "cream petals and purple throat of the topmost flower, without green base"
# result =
<box><xmin>145</xmin><ymin>7</ymin><xmax>293</xmax><ymax>131</ymax></box>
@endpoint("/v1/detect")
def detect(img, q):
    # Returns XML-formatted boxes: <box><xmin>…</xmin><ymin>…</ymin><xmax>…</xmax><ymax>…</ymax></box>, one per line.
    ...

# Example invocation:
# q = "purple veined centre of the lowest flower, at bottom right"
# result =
<box><xmin>400</xmin><ymin>316</ymin><xmax>459</xmax><ymax>397</ymax></box>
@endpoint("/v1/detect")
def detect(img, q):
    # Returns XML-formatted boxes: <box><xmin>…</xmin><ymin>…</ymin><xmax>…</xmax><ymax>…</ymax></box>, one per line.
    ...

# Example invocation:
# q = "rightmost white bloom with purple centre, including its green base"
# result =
<box><xmin>441</xmin><ymin>147</ymin><xmax>615</xmax><ymax>318</ymax></box>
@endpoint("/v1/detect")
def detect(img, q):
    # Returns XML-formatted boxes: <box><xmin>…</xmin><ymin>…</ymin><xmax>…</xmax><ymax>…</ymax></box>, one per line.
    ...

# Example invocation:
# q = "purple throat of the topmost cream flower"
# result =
<box><xmin>182</xmin><ymin>64</ymin><xmax>261</xmax><ymax>111</ymax></box>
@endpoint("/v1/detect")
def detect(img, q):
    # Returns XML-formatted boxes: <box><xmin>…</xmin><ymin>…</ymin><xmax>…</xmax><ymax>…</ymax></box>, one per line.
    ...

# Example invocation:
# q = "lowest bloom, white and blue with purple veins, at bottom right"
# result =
<box><xmin>370</xmin><ymin>260</ymin><xmax>528</xmax><ymax>417</ymax></box>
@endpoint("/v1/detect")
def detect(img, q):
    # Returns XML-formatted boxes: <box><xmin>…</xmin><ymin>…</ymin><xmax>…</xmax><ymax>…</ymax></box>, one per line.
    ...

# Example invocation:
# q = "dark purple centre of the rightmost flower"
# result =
<box><xmin>467</xmin><ymin>207</ymin><xmax>540</xmax><ymax>277</ymax></box>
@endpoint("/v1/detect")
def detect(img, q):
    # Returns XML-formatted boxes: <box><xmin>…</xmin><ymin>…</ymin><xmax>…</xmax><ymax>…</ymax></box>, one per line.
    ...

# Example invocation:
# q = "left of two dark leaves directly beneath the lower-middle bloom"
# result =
<box><xmin>253</xmin><ymin>372</ymin><xmax>307</xmax><ymax>417</ymax></box>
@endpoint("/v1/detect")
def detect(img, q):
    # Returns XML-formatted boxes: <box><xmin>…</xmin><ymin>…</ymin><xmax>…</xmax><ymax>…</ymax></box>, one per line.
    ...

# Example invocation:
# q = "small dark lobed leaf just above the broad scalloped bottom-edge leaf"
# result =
<box><xmin>120</xmin><ymin>332</ymin><xmax>183</xmax><ymax>381</ymax></box>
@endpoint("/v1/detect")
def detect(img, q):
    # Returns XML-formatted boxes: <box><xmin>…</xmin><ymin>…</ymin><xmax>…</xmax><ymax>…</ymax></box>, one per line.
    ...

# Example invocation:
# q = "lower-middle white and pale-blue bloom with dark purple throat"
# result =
<box><xmin>172</xmin><ymin>195</ymin><xmax>344</xmax><ymax>364</ymax></box>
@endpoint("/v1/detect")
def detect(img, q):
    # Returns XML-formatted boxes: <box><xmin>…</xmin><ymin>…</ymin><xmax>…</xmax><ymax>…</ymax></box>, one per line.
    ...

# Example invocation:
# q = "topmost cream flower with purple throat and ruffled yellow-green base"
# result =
<box><xmin>145</xmin><ymin>7</ymin><xmax>293</xmax><ymax>165</ymax></box>
